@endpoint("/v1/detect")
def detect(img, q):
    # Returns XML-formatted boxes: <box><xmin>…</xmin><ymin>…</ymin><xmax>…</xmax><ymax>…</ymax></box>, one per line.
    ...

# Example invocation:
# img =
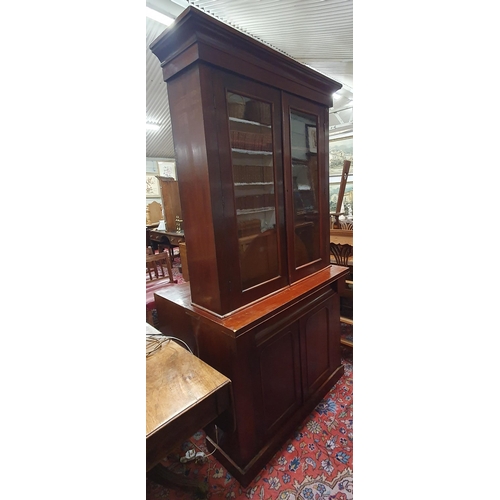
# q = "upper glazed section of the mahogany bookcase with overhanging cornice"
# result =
<box><xmin>151</xmin><ymin>7</ymin><xmax>341</xmax><ymax>316</ymax></box>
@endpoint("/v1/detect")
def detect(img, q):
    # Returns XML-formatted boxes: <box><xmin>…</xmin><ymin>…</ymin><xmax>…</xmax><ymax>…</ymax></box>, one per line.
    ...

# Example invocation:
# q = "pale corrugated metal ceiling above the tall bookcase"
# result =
<box><xmin>146</xmin><ymin>0</ymin><xmax>353</xmax><ymax>158</ymax></box>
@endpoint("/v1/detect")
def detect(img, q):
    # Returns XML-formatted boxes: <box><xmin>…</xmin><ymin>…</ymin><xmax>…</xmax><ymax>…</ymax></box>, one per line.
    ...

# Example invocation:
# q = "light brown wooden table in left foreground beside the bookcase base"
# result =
<box><xmin>146</xmin><ymin>323</ymin><xmax>232</xmax><ymax>474</ymax></box>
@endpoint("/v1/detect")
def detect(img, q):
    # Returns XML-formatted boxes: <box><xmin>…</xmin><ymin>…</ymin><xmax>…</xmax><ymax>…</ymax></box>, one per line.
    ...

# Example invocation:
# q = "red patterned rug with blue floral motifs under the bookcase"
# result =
<box><xmin>146</xmin><ymin>346</ymin><xmax>353</xmax><ymax>500</ymax></box>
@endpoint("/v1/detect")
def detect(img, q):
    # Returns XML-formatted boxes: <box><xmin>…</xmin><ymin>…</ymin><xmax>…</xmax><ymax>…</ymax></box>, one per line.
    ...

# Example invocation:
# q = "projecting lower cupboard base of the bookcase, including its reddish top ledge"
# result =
<box><xmin>155</xmin><ymin>269</ymin><xmax>345</xmax><ymax>486</ymax></box>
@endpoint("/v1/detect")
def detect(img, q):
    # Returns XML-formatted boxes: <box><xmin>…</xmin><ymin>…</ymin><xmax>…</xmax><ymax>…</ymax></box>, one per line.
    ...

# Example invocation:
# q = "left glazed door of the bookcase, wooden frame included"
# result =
<box><xmin>212</xmin><ymin>69</ymin><xmax>288</xmax><ymax>307</ymax></box>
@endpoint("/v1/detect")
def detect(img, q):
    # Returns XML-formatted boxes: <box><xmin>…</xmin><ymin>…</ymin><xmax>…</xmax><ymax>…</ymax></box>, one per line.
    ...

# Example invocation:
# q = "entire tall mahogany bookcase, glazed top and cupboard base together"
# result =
<box><xmin>150</xmin><ymin>7</ymin><xmax>347</xmax><ymax>484</ymax></box>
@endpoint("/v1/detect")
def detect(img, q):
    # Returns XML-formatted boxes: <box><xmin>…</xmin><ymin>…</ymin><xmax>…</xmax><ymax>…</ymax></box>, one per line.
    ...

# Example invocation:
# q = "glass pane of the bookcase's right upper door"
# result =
<box><xmin>290</xmin><ymin>111</ymin><xmax>320</xmax><ymax>268</ymax></box>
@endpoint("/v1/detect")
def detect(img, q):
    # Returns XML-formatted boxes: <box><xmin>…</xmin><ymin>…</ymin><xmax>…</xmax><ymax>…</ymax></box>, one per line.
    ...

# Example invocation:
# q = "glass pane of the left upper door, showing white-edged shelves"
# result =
<box><xmin>227</xmin><ymin>92</ymin><xmax>279</xmax><ymax>290</ymax></box>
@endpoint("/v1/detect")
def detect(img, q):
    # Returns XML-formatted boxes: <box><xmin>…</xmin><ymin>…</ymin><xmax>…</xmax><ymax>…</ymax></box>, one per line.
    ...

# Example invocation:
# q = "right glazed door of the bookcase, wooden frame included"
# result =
<box><xmin>283</xmin><ymin>94</ymin><xmax>329</xmax><ymax>282</ymax></box>
